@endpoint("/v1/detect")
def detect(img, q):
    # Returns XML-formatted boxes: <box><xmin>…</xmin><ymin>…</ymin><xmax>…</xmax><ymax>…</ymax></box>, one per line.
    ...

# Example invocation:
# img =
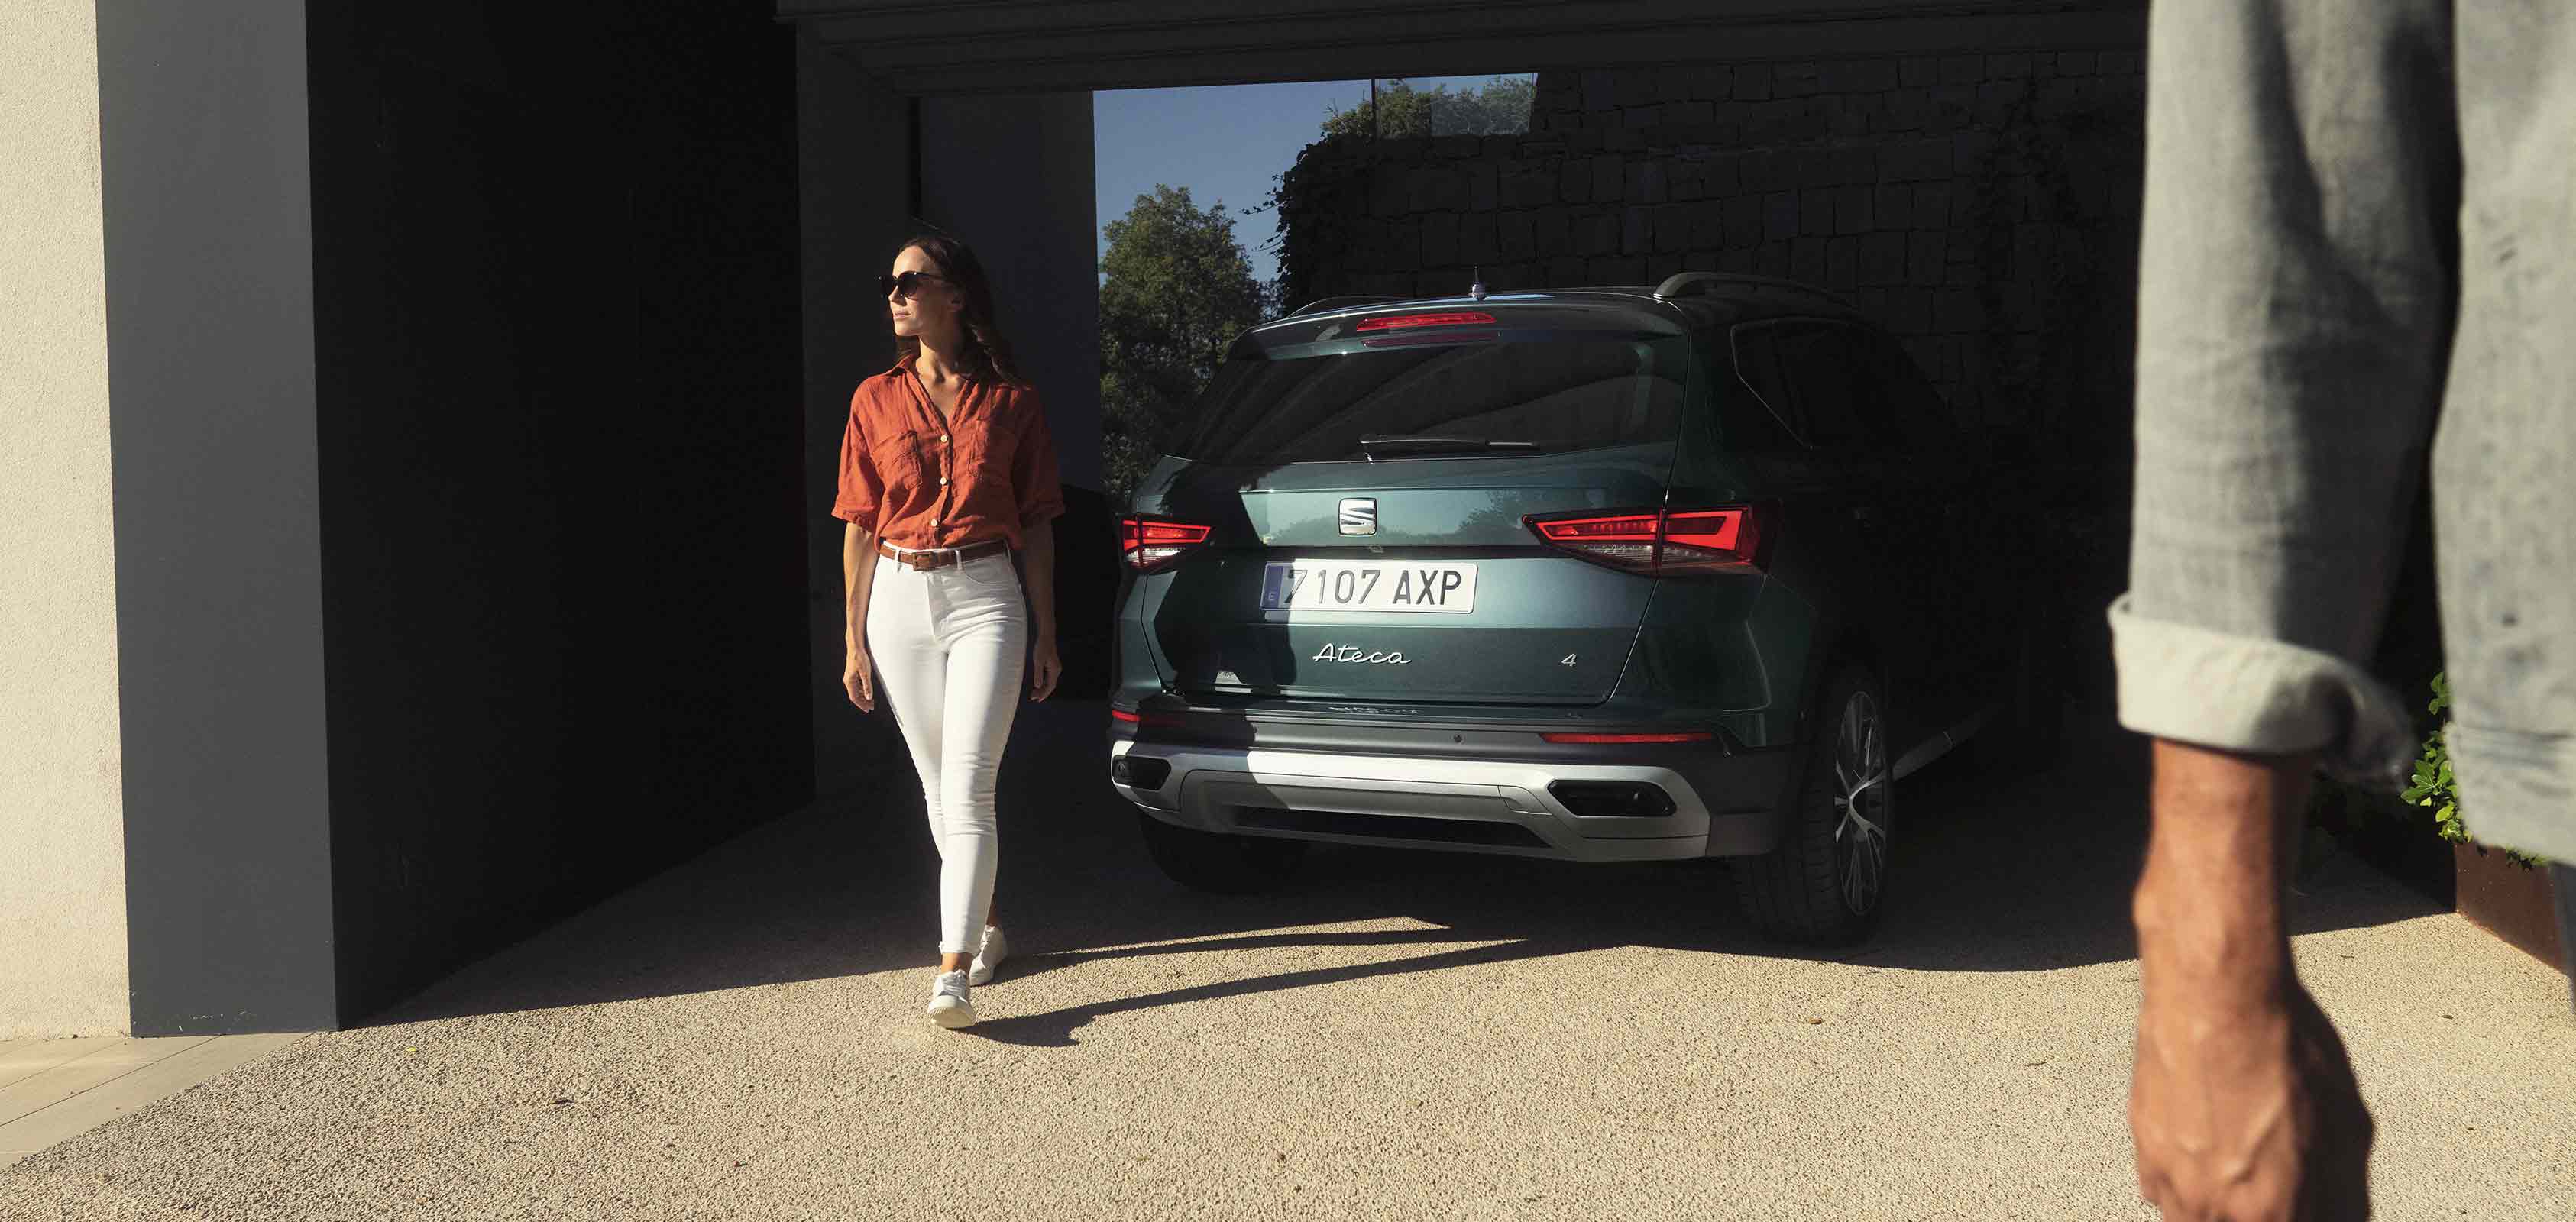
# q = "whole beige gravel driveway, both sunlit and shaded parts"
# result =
<box><xmin>0</xmin><ymin>704</ymin><xmax>2576</xmax><ymax>1222</ymax></box>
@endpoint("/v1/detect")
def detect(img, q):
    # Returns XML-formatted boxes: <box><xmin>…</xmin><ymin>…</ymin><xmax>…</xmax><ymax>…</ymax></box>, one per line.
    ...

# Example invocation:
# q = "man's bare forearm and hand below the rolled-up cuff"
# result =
<box><xmin>2128</xmin><ymin>742</ymin><xmax>2373</xmax><ymax>1222</ymax></box>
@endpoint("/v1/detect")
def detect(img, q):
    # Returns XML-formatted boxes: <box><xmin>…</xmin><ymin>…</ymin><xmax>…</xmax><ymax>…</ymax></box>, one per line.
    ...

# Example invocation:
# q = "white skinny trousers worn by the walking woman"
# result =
<box><xmin>868</xmin><ymin>551</ymin><xmax>1027</xmax><ymax>954</ymax></box>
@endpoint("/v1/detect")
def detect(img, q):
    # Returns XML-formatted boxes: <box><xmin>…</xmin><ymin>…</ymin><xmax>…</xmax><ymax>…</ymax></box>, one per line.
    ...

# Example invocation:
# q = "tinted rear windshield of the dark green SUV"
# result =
<box><xmin>1175</xmin><ymin>332</ymin><xmax>1688</xmax><ymax>467</ymax></box>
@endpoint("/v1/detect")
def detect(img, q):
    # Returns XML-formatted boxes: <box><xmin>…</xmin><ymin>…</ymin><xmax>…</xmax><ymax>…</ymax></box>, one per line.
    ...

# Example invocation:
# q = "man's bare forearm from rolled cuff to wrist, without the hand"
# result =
<box><xmin>2133</xmin><ymin>740</ymin><xmax>2315</xmax><ymax>1008</ymax></box>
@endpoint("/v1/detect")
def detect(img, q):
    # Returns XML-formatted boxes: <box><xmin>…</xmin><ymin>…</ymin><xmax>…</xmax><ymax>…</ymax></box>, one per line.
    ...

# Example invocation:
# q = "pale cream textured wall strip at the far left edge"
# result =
<box><xmin>0</xmin><ymin>0</ymin><xmax>129</xmax><ymax>1039</ymax></box>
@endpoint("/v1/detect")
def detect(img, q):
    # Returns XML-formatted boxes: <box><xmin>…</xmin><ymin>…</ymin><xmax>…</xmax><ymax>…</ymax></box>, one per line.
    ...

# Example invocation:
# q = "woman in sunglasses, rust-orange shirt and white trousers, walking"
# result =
<box><xmin>832</xmin><ymin>238</ymin><xmax>1064</xmax><ymax>1029</ymax></box>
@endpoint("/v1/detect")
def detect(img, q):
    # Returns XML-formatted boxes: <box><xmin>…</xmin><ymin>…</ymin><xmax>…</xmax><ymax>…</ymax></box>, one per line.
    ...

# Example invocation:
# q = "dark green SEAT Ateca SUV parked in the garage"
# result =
<box><xmin>1110</xmin><ymin>273</ymin><xmax>2056</xmax><ymax>941</ymax></box>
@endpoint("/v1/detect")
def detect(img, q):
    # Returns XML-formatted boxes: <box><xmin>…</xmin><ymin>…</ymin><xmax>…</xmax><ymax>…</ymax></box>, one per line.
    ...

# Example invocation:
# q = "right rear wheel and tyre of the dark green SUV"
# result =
<box><xmin>1731</xmin><ymin>665</ymin><xmax>1896</xmax><ymax>946</ymax></box>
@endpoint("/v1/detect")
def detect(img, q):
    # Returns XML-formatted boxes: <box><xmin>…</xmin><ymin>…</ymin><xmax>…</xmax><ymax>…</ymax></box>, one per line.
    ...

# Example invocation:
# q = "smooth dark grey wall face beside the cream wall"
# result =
<box><xmin>98</xmin><ymin>0</ymin><xmax>335</xmax><ymax>1036</ymax></box>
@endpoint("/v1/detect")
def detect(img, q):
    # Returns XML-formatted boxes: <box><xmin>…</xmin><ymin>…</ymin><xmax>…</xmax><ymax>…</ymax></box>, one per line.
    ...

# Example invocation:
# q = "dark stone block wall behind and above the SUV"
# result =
<box><xmin>1280</xmin><ymin>49</ymin><xmax>2144</xmax><ymax>459</ymax></box>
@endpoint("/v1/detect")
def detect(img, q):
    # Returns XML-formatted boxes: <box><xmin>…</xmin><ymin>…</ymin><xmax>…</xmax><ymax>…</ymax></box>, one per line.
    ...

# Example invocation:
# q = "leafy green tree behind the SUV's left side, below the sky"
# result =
<box><xmin>1100</xmin><ymin>183</ymin><xmax>1270</xmax><ymax>500</ymax></box>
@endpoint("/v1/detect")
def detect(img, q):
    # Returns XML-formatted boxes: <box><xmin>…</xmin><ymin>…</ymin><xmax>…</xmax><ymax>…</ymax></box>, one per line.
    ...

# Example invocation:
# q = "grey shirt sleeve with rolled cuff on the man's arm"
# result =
<box><xmin>2110</xmin><ymin>0</ymin><xmax>2458</xmax><ymax>781</ymax></box>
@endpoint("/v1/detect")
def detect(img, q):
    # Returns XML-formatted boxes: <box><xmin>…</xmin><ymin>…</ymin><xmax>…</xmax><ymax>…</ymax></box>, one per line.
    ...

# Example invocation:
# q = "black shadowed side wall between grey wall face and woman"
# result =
<box><xmin>309</xmin><ymin>5</ymin><xmax>814</xmax><ymax>1031</ymax></box>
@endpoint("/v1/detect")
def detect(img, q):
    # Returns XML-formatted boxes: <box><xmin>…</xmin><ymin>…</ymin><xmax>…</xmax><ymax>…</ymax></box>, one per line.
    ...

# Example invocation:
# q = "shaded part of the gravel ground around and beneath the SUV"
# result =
<box><xmin>368</xmin><ymin>701</ymin><xmax>2439</xmax><ymax>1044</ymax></box>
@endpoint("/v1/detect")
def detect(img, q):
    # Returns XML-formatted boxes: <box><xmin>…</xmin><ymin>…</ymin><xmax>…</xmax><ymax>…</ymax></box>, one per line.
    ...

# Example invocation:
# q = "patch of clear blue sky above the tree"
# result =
<box><xmin>1092</xmin><ymin>77</ymin><xmax>1525</xmax><ymax>281</ymax></box>
